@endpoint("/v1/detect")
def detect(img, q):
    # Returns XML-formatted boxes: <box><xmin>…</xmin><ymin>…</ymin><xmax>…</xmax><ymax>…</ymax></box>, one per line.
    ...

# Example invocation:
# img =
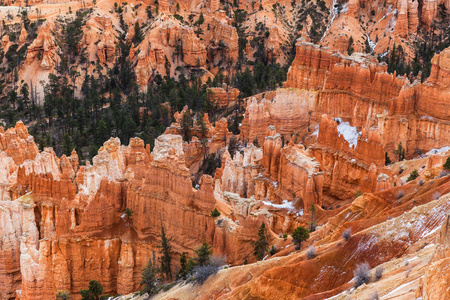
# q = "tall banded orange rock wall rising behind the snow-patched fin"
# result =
<box><xmin>248</xmin><ymin>41</ymin><xmax>449</xmax><ymax>164</ymax></box>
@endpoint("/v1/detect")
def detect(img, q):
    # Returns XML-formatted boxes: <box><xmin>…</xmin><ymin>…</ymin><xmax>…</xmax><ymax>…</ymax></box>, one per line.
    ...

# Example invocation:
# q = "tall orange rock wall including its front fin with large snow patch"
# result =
<box><xmin>241</xmin><ymin>42</ymin><xmax>449</xmax><ymax>199</ymax></box>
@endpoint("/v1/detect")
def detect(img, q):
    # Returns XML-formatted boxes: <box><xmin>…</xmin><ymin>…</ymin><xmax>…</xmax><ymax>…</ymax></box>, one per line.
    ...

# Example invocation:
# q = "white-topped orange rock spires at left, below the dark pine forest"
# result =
<box><xmin>0</xmin><ymin>122</ymin><xmax>288</xmax><ymax>299</ymax></box>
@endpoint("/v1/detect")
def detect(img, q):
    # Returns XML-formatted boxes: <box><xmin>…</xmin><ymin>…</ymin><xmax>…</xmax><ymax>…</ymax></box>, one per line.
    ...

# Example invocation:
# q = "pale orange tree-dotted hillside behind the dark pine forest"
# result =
<box><xmin>0</xmin><ymin>0</ymin><xmax>450</xmax><ymax>97</ymax></box>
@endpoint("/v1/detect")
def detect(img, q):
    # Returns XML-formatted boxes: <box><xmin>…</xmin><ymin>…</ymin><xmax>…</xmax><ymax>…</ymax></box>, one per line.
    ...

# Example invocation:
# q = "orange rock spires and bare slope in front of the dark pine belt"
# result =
<box><xmin>0</xmin><ymin>34</ymin><xmax>450</xmax><ymax>299</ymax></box>
